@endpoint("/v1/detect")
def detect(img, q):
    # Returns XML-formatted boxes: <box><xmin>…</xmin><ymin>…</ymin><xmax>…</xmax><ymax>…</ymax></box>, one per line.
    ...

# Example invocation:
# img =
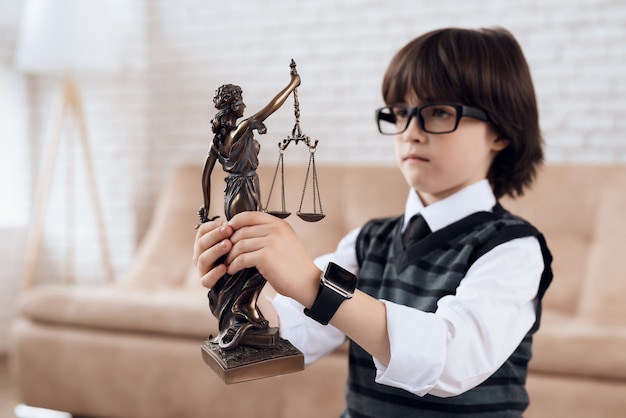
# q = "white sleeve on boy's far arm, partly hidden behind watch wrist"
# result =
<box><xmin>271</xmin><ymin>229</ymin><xmax>360</xmax><ymax>365</ymax></box>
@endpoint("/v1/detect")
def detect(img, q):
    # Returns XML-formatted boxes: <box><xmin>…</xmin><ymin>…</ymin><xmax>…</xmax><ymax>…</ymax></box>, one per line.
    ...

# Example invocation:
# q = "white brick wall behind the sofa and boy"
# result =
<box><xmin>0</xmin><ymin>0</ymin><xmax>626</xmax><ymax>349</ymax></box>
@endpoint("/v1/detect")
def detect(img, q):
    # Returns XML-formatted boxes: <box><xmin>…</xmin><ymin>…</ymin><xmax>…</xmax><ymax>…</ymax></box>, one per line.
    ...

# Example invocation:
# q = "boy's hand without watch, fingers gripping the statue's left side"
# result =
<box><xmin>193</xmin><ymin>220</ymin><xmax>233</xmax><ymax>289</ymax></box>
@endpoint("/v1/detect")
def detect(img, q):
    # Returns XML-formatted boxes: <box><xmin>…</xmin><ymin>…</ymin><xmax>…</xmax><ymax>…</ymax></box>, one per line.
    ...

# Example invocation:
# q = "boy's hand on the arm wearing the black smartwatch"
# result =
<box><xmin>224</xmin><ymin>212</ymin><xmax>320</xmax><ymax>307</ymax></box>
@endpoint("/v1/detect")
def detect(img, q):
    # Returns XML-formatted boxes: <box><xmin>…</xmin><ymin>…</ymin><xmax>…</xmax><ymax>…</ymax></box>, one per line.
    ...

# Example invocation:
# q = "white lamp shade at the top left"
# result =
<box><xmin>16</xmin><ymin>0</ymin><xmax>122</xmax><ymax>74</ymax></box>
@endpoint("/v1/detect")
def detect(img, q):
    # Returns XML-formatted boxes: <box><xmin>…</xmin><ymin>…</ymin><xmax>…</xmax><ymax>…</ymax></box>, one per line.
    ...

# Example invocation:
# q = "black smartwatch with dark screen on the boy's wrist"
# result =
<box><xmin>304</xmin><ymin>262</ymin><xmax>356</xmax><ymax>325</ymax></box>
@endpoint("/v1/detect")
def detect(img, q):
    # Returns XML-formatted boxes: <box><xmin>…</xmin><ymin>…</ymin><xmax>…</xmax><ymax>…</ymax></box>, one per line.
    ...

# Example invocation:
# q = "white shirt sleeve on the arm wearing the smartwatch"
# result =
<box><xmin>374</xmin><ymin>237</ymin><xmax>544</xmax><ymax>397</ymax></box>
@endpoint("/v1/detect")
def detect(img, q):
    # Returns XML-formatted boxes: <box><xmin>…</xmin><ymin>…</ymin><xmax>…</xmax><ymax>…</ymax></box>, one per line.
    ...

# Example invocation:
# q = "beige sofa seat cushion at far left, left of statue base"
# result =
<box><xmin>18</xmin><ymin>285</ymin><xmax>217</xmax><ymax>340</ymax></box>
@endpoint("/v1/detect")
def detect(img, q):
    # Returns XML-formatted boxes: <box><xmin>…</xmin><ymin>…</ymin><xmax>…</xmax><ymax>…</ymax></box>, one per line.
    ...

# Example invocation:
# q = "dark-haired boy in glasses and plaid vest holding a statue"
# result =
<box><xmin>194</xmin><ymin>29</ymin><xmax>552</xmax><ymax>418</ymax></box>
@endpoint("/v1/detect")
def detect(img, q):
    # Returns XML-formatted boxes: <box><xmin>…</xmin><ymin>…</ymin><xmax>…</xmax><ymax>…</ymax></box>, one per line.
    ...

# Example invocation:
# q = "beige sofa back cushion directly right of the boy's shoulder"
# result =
<box><xmin>502</xmin><ymin>165</ymin><xmax>611</xmax><ymax>314</ymax></box>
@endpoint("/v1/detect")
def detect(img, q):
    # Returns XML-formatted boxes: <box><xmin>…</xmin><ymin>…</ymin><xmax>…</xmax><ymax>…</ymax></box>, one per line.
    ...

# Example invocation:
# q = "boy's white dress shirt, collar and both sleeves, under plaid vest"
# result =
<box><xmin>272</xmin><ymin>180</ymin><xmax>544</xmax><ymax>397</ymax></box>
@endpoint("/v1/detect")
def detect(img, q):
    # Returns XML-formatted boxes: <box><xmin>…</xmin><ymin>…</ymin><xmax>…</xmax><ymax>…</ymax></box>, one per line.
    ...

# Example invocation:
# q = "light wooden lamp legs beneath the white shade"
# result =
<box><xmin>22</xmin><ymin>78</ymin><xmax>113</xmax><ymax>289</ymax></box>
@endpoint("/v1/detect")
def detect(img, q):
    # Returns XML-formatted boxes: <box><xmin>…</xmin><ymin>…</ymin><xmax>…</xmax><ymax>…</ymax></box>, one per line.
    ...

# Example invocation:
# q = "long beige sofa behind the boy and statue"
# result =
<box><xmin>10</xmin><ymin>162</ymin><xmax>626</xmax><ymax>418</ymax></box>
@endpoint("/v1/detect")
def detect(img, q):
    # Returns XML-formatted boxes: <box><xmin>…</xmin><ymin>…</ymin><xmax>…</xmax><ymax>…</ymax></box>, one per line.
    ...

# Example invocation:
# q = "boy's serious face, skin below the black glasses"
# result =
<box><xmin>395</xmin><ymin>96</ymin><xmax>508</xmax><ymax>205</ymax></box>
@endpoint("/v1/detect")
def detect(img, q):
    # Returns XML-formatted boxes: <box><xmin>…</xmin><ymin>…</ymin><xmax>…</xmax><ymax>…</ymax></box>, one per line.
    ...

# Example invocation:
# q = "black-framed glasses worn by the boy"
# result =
<box><xmin>376</xmin><ymin>103</ymin><xmax>489</xmax><ymax>135</ymax></box>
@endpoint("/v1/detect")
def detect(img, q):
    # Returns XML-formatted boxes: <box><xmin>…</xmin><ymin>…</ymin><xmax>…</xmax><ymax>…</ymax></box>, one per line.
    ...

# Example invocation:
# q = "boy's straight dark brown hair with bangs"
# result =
<box><xmin>382</xmin><ymin>28</ymin><xmax>543</xmax><ymax>198</ymax></box>
